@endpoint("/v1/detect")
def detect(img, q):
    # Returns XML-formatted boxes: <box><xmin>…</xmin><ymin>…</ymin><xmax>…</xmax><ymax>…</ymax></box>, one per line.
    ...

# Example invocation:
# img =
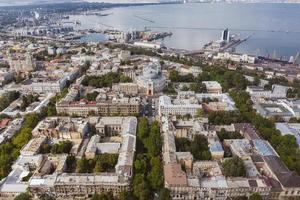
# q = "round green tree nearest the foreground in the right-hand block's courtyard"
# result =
<box><xmin>223</xmin><ymin>156</ymin><xmax>246</xmax><ymax>177</ymax></box>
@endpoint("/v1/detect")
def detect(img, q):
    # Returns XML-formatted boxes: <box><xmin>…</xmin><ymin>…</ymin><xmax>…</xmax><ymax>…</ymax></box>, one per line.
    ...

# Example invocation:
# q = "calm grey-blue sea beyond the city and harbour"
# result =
<box><xmin>70</xmin><ymin>3</ymin><xmax>300</xmax><ymax>59</ymax></box>
